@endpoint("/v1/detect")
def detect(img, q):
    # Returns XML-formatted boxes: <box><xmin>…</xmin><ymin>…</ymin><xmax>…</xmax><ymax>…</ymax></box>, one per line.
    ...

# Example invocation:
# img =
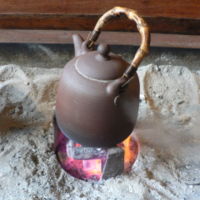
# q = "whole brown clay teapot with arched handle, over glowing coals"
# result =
<box><xmin>55</xmin><ymin>7</ymin><xmax>150</xmax><ymax>147</ymax></box>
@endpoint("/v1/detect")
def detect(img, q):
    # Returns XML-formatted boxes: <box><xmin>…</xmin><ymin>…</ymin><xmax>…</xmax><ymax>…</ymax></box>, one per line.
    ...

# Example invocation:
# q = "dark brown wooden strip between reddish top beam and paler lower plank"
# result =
<box><xmin>0</xmin><ymin>14</ymin><xmax>200</xmax><ymax>35</ymax></box>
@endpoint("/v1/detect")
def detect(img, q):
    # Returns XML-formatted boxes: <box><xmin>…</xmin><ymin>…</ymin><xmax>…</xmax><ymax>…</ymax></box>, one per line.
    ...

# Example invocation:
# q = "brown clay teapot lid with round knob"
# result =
<box><xmin>75</xmin><ymin>44</ymin><xmax>129</xmax><ymax>81</ymax></box>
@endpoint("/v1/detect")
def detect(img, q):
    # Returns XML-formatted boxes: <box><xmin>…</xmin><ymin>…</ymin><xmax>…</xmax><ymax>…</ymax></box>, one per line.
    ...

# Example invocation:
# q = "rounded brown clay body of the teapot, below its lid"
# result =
<box><xmin>56</xmin><ymin>57</ymin><xmax>139</xmax><ymax>147</ymax></box>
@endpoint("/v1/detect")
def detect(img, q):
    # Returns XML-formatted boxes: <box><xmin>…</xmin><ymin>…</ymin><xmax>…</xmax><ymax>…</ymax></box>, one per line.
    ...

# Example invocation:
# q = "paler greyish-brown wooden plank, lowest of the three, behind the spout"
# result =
<box><xmin>0</xmin><ymin>29</ymin><xmax>200</xmax><ymax>49</ymax></box>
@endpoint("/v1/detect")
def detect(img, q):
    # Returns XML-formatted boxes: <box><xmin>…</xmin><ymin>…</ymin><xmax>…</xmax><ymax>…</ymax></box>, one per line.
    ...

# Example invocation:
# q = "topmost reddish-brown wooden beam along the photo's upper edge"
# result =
<box><xmin>0</xmin><ymin>0</ymin><xmax>200</xmax><ymax>19</ymax></box>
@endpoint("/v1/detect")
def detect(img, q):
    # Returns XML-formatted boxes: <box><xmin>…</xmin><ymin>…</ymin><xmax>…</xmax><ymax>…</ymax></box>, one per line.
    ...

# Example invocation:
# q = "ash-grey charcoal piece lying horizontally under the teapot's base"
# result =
<box><xmin>67</xmin><ymin>141</ymin><xmax>106</xmax><ymax>160</ymax></box>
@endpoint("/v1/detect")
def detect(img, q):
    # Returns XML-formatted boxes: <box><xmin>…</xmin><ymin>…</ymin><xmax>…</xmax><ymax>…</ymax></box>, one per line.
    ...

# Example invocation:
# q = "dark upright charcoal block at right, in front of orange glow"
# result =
<box><xmin>101</xmin><ymin>147</ymin><xmax>124</xmax><ymax>179</ymax></box>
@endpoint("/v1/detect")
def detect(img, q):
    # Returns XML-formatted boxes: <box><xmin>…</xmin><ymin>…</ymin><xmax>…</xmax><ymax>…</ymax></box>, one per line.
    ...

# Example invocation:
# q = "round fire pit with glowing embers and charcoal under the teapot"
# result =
<box><xmin>53</xmin><ymin>117</ymin><xmax>139</xmax><ymax>181</ymax></box>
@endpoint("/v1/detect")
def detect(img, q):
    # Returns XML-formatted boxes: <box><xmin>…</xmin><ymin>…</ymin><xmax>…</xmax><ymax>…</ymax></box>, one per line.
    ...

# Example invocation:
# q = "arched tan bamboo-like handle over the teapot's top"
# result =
<box><xmin>87</xmin><ymin>7</ymin><xmax>150</xmax><ymax>82</ymax></box>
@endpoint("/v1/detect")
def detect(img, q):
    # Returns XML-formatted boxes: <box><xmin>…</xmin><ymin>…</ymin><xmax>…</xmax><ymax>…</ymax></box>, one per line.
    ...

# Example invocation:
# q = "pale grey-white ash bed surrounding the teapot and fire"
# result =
<box><xmin>0</xmin><ymin>65</ymin><xmax>200</xmax><ymax>200</ymax></box>
